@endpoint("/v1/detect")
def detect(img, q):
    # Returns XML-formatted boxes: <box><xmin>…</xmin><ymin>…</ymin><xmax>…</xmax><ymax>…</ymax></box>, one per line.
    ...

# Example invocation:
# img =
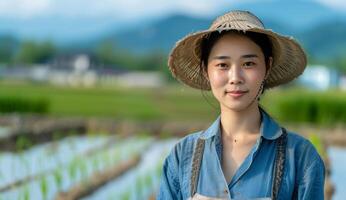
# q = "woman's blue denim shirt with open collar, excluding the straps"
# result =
<box><xmin>157</xmin><ymin>109</ymin><xmax>325</xmax><ymax>200</ymax></box>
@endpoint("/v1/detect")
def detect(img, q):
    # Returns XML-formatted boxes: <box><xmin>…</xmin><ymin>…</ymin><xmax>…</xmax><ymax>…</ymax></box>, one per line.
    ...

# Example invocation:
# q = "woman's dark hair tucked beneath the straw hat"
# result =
<box><xmin>200</xmin><ymin>30</ymin><xmax>272</xmax><ymax>93</ymax></box>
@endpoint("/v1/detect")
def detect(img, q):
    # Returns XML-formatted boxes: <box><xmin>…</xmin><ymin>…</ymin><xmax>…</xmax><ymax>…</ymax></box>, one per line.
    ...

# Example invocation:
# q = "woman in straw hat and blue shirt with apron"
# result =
<box><xmin>158</xmin><ymin>11</ymin><xmax>325</xmax><ymax>199</ymax></box>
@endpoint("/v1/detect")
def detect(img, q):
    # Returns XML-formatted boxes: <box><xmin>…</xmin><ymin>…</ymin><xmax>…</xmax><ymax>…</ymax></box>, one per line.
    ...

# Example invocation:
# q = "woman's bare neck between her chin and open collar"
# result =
<box><xmin>220</xmin><ymin>104</ymin><xmax>261</xmax><ymax>138</ymax></box>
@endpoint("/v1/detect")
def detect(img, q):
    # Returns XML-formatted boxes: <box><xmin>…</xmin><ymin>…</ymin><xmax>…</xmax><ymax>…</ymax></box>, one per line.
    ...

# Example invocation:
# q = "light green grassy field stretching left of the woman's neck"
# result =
<box><xmin>0</xmin><ymin>83</ymin><xmax>217</xmax><ymax>120</ymax></box>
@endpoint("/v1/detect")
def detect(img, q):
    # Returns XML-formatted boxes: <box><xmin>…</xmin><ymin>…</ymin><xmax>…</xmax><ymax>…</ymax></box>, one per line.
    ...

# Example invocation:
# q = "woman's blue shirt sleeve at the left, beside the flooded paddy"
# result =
<box><xmin>157</xmin><ymin>146</ymin><xmax>182</xmax><ymax>200</ymax></box>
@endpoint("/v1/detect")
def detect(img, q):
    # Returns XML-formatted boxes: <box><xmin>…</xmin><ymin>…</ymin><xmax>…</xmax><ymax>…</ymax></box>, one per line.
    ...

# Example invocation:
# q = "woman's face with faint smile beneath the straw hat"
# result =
<box><xmin>207</xmin><ymin>33</ymin><xmax>271</xmax><ymax>111</ymax></box>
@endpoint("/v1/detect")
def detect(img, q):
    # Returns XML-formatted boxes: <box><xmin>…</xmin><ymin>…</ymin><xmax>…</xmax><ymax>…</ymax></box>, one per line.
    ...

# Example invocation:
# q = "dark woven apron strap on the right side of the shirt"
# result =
<box><xmin>272</xmin><ymin>127</ymin><xmax>287</xmax><ymax>200</ymax></box>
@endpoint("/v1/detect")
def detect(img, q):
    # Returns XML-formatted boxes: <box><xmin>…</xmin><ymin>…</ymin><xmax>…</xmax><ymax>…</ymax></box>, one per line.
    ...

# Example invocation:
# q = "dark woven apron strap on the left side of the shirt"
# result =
<box><xmin>190</xmin><ymin>138</ymin><xmax>205</xmax><ymax>197</ymax></box>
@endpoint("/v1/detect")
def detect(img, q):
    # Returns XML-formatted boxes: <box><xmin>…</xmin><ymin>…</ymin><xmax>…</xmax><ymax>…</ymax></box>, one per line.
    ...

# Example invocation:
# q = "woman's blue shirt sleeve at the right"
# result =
<box><xmin>296</xmin><ymin>145</ymin><xmax>325</xmax><ymax>200</ymax></box>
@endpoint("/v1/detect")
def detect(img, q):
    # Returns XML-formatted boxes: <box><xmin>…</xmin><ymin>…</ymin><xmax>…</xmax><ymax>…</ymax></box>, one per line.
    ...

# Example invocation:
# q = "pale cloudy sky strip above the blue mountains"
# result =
<box><xmin>0</xmin><ymin>0</ymin><xmax>346</xmax><ymax>21</ymax></box>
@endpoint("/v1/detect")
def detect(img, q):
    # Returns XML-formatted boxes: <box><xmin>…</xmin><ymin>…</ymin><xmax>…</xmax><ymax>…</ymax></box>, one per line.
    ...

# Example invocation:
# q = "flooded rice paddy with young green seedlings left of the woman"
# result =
<box><xmin>0</xmin><ymin>126</ymin><xmax>176</xmax><ymax>200</ymax></box>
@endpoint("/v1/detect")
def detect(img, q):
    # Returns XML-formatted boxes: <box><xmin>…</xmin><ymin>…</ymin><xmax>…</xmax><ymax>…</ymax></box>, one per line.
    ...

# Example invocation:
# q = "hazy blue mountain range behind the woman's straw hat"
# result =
<box><xmin>0</xmin><ymin>0</ymin><xmax>346</xmax><ymax>58</ymax></box>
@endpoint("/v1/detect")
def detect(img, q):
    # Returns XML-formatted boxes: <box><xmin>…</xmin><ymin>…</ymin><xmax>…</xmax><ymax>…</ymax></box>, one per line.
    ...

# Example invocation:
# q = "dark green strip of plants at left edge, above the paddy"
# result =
<box><xmin>0</xmin><ymin>96</ymin><xmax>49</xmax><ymax>113</ymax></box>
